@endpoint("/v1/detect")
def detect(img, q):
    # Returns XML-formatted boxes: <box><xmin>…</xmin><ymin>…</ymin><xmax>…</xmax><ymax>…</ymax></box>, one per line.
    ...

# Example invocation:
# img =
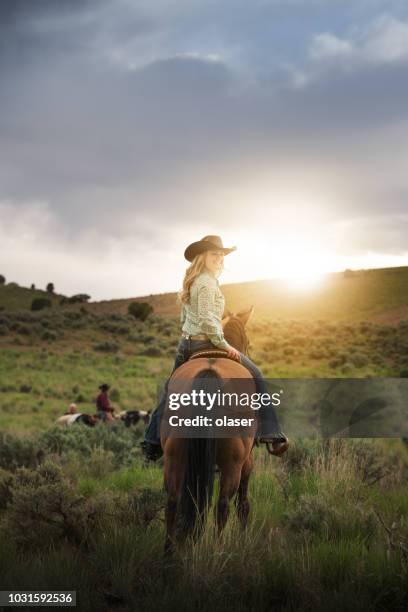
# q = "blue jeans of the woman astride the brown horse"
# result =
<box><xmin>144</xmin><ymin>338</ymin><xmax>282</xmax><ymax>444</ymax></box>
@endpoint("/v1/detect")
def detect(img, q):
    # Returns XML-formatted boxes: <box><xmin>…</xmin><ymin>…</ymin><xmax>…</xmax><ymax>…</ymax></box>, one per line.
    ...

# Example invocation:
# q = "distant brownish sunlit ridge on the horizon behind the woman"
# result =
<box><xmin>64</xmin><ymin>267</ymin><xmax>408</xmax><ymax>323</ymax></box>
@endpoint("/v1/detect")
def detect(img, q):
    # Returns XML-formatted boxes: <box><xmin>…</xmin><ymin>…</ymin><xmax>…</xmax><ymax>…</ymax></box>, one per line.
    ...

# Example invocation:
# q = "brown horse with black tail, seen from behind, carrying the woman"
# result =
<box><xmin>161</xmin><ymin>307</ymin><xmax>286</xmax><ymax>551</ymax></box>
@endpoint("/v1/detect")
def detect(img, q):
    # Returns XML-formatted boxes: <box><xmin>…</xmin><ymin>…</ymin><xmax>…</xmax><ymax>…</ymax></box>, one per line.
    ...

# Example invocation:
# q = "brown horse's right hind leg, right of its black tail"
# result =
<box><xmin>216</xmin><ymin>438</ymin><xmax>246</xmax><ymax>533</ymax></box>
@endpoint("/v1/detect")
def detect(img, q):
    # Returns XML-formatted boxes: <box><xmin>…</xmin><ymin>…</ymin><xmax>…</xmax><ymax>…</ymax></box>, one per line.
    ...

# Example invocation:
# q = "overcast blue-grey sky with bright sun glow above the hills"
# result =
<box><xmin>0</xmin><ymin>0</ymin><xmax>408</xmax><ymax>299</ymax></box>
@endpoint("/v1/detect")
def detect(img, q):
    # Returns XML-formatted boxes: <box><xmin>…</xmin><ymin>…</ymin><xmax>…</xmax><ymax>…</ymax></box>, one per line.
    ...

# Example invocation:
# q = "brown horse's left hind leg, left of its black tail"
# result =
<box><xmin>164</xmin><ymin>438</ymin><xmax>184</xmax><ymax>553</ymax></box>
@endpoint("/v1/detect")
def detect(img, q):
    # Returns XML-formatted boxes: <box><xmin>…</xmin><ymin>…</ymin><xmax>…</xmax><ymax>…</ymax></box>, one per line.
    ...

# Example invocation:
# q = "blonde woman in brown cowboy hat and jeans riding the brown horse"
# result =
<box><xmin>141</xmin><ymin>236</ymin><xmax>288</xmax><ymax>461</ymax></box>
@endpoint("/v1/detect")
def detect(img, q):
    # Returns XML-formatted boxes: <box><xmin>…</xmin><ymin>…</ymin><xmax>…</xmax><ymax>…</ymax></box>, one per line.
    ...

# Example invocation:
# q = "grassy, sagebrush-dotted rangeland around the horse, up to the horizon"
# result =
<box><xmin>0</xmin><ymin>268</ymin><xmax>408</xmax><ymax>612</ymax></box>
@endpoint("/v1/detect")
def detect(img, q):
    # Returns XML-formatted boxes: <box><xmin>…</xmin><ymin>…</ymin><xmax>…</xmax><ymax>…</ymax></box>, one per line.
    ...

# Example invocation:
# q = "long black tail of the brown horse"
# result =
<box><xmin>180</xmin><ymin>369</ymin><xmax>220</xmax><ymax>535</ymax></box>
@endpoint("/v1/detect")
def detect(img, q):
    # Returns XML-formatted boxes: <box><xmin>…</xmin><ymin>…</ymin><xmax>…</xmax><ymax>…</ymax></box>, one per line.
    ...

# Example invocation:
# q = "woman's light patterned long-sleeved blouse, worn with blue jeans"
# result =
<box><xmin>180</xmin><ymin>271</ymin><xmax>228</xmax><ymax>348</ymax></box>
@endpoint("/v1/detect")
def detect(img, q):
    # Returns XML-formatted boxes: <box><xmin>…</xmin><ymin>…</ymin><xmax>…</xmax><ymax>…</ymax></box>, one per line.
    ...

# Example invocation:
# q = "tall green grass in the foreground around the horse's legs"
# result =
<box><xmin>0</xmin><ymin>428</ymin><xmax>408</xmax><ymax>611</ymax></box>
